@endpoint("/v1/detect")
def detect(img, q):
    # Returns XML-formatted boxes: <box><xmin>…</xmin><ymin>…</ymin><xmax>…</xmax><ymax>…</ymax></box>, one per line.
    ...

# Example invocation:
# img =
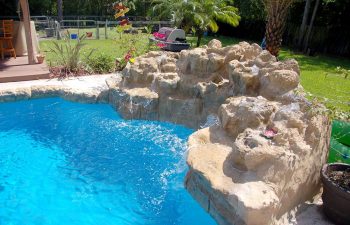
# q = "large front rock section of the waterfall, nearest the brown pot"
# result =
<box><xmin>185</xmin><ymin>96</ymin><xmax>330</xmax><ymax>224</ymax></box>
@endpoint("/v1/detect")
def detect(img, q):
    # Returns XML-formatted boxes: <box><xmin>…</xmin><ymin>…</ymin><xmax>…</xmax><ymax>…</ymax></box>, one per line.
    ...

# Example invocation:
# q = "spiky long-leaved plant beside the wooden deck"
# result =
<box><xmin>50</xmin><ymin>32</ymin><xmax>93</xmax><ymax>73</ymax></box>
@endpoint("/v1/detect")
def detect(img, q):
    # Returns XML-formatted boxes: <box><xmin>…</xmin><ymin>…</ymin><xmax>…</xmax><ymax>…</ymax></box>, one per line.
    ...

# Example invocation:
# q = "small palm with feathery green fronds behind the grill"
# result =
<box><xmin>153</xmin><ymin>0</ymin><xmax>240</xmax><ymax>47</ymax></box>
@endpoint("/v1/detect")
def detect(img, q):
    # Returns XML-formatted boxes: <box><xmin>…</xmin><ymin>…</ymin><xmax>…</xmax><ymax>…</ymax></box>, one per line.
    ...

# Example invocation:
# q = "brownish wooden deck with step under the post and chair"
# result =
<box><xmin>0</xmin><ymin>56</ymin><xmax>50</xmax><ymax>83</ymax></box>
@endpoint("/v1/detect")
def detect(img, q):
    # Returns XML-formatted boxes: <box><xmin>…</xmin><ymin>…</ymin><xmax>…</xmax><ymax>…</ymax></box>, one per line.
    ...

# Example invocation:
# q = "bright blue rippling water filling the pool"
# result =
<box><xmin>0</xmin><ymin>98</ymin><xmax>215</xmax><ymax>225</ymax></box>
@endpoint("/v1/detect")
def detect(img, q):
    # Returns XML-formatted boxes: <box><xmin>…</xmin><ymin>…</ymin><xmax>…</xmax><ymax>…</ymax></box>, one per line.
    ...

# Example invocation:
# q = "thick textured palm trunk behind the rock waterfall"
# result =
<box><xmin>264</xmin><ymin>0</ymin><xmax>294</xmax><ymax>56</ymax></box>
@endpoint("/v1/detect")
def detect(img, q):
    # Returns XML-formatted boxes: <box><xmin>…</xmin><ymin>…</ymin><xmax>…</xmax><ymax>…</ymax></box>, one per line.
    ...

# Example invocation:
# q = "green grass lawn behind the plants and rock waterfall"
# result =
<box><xmin>40</xmin><ymin>34</ymin><xmax>350</xmax><ymax>112</ymax></box>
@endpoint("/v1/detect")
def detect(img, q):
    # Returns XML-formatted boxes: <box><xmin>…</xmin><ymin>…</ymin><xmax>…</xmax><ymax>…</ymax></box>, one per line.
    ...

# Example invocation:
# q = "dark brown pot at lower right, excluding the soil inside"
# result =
<box><xmin>321</xmin><ymin>163</ymin><xmax>350</xmax><ymax>225</ymax></box>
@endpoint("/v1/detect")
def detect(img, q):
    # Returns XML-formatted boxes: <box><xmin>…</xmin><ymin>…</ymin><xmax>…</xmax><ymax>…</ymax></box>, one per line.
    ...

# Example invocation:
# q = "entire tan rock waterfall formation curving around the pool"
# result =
<box><xmin>109</xmin><ymin>40</ymin><xmax>330</xmax><ymax>225</ymax></box>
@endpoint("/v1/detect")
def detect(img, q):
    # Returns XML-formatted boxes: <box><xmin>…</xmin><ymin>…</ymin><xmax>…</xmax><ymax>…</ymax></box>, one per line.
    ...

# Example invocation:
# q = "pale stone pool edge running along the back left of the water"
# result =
<box><xmin>0</xmin><ymin>74</ymin><xmax>119</xmax><ymax>103</ymax></box>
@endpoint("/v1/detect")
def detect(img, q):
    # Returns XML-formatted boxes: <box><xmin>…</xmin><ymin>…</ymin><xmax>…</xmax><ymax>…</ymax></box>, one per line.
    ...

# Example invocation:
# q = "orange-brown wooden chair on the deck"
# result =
<box><xmin>0</xmin><ymin>20</ymin><xmax>16</xmax><ymax>59</ymax></box>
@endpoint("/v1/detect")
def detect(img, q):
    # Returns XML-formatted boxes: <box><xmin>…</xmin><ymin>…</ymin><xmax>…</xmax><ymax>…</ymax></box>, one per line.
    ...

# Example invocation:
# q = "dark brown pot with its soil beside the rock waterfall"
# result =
<box><xmin>321</xmin><ymin>163</ymin><xmax>350</xmax><ymax>225</ymax></box>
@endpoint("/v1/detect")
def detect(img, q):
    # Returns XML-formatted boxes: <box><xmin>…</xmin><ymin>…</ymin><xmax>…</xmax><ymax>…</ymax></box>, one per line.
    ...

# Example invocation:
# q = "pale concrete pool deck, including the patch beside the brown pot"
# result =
<box><xmin>0</xmin><ymin>74</ymin><xmax>333</xmax><ymax>225</ymax></box>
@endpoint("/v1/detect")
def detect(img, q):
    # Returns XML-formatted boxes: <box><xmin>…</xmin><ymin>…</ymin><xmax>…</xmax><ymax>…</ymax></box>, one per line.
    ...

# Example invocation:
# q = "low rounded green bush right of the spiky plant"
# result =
<box><xmin>87</xmin><ymin>53</ymin><xmax>115</xmax><ymax>74</ymax></box>
